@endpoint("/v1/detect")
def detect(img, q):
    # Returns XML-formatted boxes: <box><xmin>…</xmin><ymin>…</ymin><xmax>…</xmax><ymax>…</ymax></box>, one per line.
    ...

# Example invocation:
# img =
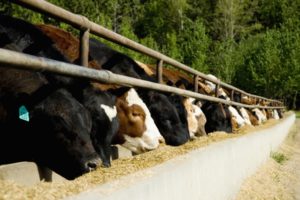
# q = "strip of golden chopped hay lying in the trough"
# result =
<box><xmin>0</xmin><ymin>111</ymin><xmax>292</xmax><ymax>200</ymax></box>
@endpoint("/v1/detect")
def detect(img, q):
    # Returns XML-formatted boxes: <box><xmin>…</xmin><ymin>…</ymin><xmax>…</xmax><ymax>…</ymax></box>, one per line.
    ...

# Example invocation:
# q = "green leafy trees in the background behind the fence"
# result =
<box><xmin>0</xmin><ymin>0</ymin><xmax>300</xmax><ymax>109</ymax></box>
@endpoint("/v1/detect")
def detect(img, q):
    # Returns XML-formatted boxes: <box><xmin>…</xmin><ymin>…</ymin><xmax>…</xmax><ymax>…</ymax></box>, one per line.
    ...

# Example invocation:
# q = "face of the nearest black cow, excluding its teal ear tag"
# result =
<box><xmin>29</xmin><ymin>89</ymin><xmax>100</xmax><ymax>179</ymax></box>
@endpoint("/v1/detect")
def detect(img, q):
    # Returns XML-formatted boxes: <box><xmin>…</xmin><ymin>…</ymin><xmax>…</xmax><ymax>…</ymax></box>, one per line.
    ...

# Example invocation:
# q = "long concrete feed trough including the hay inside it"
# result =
<box><xmin>0</xmin><ymin>114</ymin><xmax>295</xmax><ymax>200</ymax></box>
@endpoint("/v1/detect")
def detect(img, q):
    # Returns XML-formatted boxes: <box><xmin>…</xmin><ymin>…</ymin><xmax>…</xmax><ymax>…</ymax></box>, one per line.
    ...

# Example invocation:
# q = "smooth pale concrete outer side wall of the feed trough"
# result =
<box><xmin>66</xmin><ymin>115</ymin><xmax>295</xmax><ymax>200</ymax></box>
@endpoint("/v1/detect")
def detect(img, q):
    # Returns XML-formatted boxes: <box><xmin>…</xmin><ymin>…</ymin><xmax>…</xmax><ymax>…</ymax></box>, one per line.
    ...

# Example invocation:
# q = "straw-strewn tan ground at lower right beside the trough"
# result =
<box><xmin>236</xmin><ymin>118</ymin><xmax>300</xmax><ymax>200</ymax></box>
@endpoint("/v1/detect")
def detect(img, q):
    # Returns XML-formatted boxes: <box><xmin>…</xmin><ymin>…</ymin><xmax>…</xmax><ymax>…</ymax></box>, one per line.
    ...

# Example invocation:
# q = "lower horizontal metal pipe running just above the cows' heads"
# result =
<box><xmin>0</xmin><ymin>48</ymin><xmax>284</xmax><ymax>108</ymax></box>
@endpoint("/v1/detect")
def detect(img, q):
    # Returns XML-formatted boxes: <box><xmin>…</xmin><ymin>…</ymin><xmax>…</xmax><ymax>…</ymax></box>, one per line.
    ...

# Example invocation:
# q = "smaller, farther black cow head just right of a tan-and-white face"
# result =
<box><xmin>201</xmin><ymin>101</ymin><xmax>232</xmax><ymax>133</ymax></box>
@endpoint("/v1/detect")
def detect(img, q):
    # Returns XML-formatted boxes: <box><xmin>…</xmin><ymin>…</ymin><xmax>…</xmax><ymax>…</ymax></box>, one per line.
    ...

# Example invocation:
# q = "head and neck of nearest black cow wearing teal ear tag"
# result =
<box><xmin>0</xmin><ymin>83</ymin><xmax>100</xmax><ymax>180</ymax></box>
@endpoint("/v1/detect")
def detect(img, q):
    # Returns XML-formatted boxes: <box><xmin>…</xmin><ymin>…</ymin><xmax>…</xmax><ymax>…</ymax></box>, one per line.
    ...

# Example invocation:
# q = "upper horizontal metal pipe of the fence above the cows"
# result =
<box><xmin>12</xmin><ymin>0</ymin><xmax>280</xmax><ymax>102</ymax></box>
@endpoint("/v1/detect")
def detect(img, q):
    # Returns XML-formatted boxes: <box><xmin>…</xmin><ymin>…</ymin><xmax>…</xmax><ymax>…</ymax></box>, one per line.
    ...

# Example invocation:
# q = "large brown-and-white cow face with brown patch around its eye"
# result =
<box><xmin>115</xmin><ymin>88</ymin><xmax>163</xmax><ymax>154</ymax></box>
